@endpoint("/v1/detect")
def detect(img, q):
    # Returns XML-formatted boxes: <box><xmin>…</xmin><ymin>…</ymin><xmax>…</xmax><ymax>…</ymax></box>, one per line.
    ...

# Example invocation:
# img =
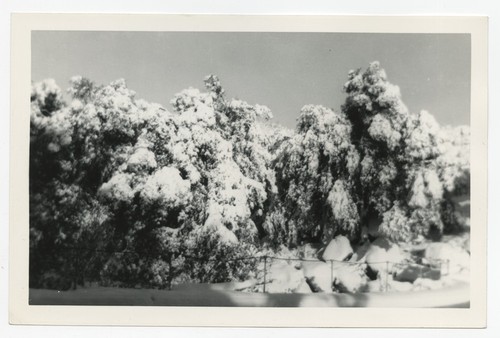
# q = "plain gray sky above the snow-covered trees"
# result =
<box><xmin>31</xmin><ymin>31</ymin><xmax>470</xmax><ymax>127</ymax></box>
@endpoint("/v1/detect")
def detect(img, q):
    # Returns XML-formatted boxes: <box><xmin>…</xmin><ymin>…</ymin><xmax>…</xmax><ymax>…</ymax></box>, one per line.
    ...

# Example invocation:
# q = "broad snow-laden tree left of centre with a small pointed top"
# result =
<box><xmin>95</xmin><ymin>76</ymin><xmax>274</xmax><ymax>286</ymax></box>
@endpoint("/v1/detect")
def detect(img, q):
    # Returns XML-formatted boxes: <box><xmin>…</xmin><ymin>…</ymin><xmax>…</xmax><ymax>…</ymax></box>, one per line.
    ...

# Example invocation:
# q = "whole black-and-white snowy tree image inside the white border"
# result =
<box><xmin>7</xmin><ymin>13</ymin><xmax>484</xmax><ymax>324</ymax></box>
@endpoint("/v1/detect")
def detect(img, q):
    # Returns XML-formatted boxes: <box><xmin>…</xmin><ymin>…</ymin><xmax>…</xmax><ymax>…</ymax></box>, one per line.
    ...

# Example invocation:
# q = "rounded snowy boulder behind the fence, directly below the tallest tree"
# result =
<box><xmin>365</xmin><ymin>238</ymin><xmax>406</xmax><ymax>274</ymax></box>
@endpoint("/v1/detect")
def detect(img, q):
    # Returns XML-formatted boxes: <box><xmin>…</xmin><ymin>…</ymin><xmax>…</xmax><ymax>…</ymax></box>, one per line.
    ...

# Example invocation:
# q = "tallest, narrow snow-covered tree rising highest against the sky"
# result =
<box><xmin>342</xmin><ymin>62</ymin><xmax>410</xmax><ymax>240</ymax></box>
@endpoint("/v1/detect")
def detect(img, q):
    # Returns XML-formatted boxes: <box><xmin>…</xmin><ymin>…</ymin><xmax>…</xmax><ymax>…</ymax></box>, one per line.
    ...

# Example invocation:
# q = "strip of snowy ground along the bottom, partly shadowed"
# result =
<box><xmin>29</xmin><ymin>283</ymin><xmax>469</xmax><ymax>307</ymax></box>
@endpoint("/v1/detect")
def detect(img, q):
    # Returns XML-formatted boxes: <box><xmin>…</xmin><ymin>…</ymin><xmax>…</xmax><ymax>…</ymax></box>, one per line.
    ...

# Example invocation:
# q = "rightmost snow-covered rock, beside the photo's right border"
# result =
<box><xmin>424</xmin><ymin>243</ymin><xmax>470</xmax><ymax>275</ymax></box>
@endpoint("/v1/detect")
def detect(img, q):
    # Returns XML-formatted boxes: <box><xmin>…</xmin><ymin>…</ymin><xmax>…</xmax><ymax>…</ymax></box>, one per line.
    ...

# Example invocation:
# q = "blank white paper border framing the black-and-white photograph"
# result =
<box><xmin>9</xmin><ymin>14</ymin><xmax>488</xmax><ymax>328</ymax></box>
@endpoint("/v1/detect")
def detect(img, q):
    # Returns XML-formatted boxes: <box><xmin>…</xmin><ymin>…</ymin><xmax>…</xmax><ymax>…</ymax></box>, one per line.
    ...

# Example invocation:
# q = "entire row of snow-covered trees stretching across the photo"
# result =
<box><xmin>30</xmin><ymin>62</ymin><xmax>470</xmax><ymax>289</ymax></box>
